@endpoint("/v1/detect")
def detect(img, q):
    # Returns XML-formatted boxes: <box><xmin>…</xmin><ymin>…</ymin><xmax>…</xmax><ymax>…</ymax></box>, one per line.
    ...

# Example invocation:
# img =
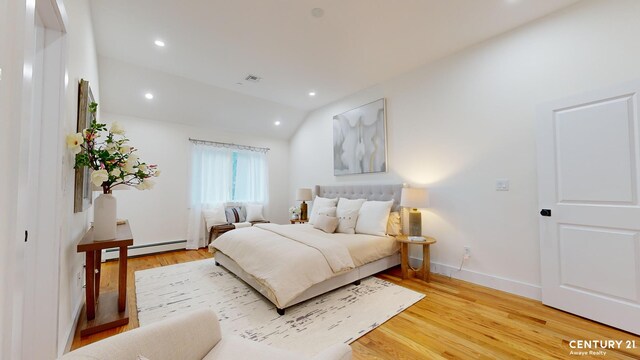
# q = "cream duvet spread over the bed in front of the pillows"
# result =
<box><xmin>210</xmin><ymin>224</ymin><xmax>398</xmax><ymax>307</ymax></box>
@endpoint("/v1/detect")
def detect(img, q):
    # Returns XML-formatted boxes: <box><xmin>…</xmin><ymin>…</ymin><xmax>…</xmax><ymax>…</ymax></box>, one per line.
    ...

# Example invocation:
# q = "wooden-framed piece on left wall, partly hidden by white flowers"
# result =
<box><xmin>73</xmin><ymin>79</ymin><xmax>95</xmax><ymax>213</ymax></box>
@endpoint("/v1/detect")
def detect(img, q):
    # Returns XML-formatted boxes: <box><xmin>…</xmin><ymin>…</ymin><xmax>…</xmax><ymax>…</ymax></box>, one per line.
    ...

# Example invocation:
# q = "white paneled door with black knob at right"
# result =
<box><xmin>537</xmin><ymin>82</ymin><xmax>640</xmax><ymax>334</ymax></box>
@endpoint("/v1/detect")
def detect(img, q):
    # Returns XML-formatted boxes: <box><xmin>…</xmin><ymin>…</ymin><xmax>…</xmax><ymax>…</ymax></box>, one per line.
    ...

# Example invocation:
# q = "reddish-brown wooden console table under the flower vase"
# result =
<box><xmin>77</xmin><ymin>221</ymin><xmax>133</xmax><ymax>336</ymax></box>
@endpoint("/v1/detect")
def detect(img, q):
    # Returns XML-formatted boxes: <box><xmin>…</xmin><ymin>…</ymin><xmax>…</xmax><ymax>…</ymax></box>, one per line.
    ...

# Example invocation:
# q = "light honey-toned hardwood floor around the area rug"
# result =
<box><xmin>72</xmin><ymin>250</ymin><xmax>640</xmax><ymax>359</ymax></box>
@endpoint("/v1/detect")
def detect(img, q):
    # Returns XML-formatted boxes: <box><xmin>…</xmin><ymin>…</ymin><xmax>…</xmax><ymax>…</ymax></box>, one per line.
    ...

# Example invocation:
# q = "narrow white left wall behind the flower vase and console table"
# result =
<box><xmin>58</xmin><ymin>0</ymin><xmax>100</xmax><ymax>352</ymax></box>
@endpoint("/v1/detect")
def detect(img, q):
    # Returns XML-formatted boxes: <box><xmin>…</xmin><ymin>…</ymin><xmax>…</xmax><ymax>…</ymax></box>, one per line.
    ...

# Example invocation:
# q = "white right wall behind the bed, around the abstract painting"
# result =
<box><xmin>289</xmin><ymin>0</ymin><xmax>640</xmax><ymax>297</ymax></box>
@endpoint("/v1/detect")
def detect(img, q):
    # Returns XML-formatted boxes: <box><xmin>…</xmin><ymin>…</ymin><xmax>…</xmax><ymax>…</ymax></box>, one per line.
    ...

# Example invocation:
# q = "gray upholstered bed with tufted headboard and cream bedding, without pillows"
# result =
<box><xmin>209</xmin><ymin>185</ymin><xmax>402</xmax><ymax>315</ymax></box>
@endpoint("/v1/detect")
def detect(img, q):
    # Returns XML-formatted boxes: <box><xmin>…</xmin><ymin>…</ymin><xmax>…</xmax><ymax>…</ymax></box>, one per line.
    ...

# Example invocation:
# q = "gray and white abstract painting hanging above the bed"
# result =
<box><xmin>333</xmin><ymin>98</ymin><xmax>388</xmax><ymax>176</ymax></box>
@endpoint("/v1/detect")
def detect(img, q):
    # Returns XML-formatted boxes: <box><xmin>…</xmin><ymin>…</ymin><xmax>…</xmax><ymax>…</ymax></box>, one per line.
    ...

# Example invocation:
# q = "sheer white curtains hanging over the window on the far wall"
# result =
<box><xmin>187</xmin><ymin>143</ymin><xmax>268</xmax><ymax>249</ymax></box>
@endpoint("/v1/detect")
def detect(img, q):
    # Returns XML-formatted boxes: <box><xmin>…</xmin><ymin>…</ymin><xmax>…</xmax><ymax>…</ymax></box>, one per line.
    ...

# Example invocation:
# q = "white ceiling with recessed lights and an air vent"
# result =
<box><xmin>91</xmin><ymin>0</ymin><xmax>577</xmax><ymax>139</ymax></box>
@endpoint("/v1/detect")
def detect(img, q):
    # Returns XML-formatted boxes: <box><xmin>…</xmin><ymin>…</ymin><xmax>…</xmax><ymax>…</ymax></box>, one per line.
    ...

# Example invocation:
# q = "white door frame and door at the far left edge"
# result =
<box><xmin>0</xmin><ymin>0</ymin><xmax>68</xmax><ymax>359</ymax></box>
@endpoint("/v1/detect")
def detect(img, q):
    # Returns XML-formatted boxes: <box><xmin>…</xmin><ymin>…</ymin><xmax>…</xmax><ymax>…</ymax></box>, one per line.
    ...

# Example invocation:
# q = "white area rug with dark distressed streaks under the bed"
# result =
<box><xmin>135</xmin><ymin>259</ymin><xmax>424</xmax><ymax>355</ymax></box>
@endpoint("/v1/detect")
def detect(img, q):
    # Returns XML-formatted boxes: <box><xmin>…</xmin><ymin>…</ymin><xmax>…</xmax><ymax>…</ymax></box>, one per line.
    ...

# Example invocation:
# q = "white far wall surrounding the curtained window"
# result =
<box><xmin>100</xmin><ymin>113</ymin><xmax>290</xmax><ymax>245</ymax></box>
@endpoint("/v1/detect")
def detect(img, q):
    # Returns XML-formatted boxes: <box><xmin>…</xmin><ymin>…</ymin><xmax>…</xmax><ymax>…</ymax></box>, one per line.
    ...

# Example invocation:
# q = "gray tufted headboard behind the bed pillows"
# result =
<box><xmin>315</xmin><ymin>184</ymin><xmax>402</xmax><ymax>211</ymax></box>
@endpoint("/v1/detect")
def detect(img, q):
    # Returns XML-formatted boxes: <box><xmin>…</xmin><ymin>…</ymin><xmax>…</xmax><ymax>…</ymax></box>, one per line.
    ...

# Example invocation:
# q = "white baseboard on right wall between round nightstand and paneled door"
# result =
<box><xmin>411</xmin><ymin>257</ymin><xmax>542</xmax><ymax>300</ymax></box>
